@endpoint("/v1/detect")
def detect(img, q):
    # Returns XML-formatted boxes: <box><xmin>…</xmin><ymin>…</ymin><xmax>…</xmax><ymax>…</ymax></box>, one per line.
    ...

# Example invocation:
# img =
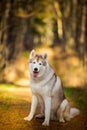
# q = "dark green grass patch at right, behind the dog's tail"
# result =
<box><xmin>64</xmin><ymin>87</ymin><xmax>87</xmax><ymax>113</ymax></box>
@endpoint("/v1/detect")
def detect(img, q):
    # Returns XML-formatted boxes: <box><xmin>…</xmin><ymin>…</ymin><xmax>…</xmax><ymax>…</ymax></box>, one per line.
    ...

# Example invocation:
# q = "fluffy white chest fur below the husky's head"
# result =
<box><xmin>30</xmin><ymin>68</ymin><xmax>55</xmax><ymax>96</ymax></box>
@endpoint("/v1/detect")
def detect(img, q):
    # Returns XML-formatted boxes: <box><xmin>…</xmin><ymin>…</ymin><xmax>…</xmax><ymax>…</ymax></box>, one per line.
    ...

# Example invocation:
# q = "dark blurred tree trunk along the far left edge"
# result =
<box><xmin>0</xmin><ymin>2</ymin><xmax>10</xmax><ymax>71</ymax></box>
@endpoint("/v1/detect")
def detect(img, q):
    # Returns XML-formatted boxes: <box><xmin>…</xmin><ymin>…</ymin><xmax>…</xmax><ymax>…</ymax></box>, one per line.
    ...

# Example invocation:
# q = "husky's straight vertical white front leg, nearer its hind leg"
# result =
<box><xmin>42</xmin><ymin>97</ymin><xmax>51</xmax><ymax>126</ymax></box>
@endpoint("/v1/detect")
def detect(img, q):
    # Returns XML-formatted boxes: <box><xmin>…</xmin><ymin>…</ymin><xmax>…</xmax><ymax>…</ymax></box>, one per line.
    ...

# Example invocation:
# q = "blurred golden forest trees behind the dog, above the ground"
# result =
<box><xmin>0</xmin><ymin>0</ymin><xmax>87</xmax><ymax>87</ymax></box>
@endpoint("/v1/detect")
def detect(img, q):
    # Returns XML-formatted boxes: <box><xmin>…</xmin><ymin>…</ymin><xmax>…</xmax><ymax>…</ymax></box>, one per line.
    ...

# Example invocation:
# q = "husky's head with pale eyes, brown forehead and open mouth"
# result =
<box><xmin>29</xmin><ymin>50</ymin><xmax>47</xmax><ymax>78</ymax></box>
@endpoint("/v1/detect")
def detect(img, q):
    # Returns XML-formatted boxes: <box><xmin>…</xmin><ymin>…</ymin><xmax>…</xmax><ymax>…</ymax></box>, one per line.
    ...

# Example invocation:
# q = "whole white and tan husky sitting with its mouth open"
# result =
<box><xmin>24</xmin><ymin>50</ymin><xmax>80</xmax><ymax>126</ymax></box>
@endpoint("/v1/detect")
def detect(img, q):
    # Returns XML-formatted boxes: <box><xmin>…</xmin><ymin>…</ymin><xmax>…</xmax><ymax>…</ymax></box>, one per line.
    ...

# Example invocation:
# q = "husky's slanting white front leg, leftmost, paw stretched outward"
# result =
<box><xmin>24</xmin><ymin>95</ymin><xmax>38</xmax><ymax>121</ymax></box>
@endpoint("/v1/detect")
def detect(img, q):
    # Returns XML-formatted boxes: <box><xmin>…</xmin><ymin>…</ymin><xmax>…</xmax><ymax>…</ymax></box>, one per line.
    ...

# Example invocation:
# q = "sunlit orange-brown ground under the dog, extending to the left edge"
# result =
<box><xmin>0</xmin><ymin>85</ymin><xmax>87</xmax><ymax>130</ymax></box>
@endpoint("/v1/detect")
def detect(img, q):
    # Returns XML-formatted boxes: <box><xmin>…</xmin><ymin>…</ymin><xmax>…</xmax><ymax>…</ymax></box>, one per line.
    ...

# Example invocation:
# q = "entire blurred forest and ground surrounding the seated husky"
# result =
<box><xmin>0</xmin><ymin>0</ymin><xmax>87</xmax><ymax>130</ymax></box>
